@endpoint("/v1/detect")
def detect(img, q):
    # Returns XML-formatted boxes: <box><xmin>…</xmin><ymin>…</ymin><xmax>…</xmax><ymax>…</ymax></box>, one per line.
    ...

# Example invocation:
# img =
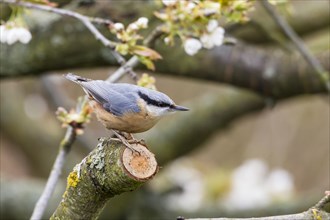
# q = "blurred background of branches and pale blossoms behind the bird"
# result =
<box><xmin>0</xmin><ymin>0</ymin><xmax>330</xmax><ymax>219</ymax></box>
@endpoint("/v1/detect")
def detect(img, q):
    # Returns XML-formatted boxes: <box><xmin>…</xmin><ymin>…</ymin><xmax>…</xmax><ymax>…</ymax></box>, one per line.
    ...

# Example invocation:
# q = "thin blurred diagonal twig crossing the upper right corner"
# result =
<box><xmin>261</xmin><ymin>0</ymin><xmax>330</xmax><ymax>92</ymax></box>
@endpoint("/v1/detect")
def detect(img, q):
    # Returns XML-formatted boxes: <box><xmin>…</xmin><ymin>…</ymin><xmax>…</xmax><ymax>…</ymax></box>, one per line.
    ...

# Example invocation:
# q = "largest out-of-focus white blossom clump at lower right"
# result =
<box><xmin>220</xmin><ymin>159</ymin><xmax>294</xmax><ymax>210</ymax></box>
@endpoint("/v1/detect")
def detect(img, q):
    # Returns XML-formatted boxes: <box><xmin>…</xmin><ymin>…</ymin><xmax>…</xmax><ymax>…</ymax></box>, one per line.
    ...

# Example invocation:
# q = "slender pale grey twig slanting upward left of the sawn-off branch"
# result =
<box><xmin>31</xmin><ymin>126</ymin><xmax>76</xmax><ymax>220</ymax></box>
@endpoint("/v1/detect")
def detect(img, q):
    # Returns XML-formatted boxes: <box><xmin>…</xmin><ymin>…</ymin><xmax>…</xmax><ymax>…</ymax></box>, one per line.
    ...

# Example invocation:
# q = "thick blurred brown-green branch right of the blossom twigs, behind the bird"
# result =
<box><xmin>156</xmin><ymin>42</ymin><xmax>330</xmax><ymax>99</ymax></box>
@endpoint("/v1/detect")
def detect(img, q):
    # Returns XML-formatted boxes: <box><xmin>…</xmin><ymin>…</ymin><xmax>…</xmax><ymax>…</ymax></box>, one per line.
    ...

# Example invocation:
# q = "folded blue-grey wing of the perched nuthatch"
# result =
<box><xmin>80</xmin><ymin>80</ymin><xmax>140</xmax><ymax>116</ymax></box>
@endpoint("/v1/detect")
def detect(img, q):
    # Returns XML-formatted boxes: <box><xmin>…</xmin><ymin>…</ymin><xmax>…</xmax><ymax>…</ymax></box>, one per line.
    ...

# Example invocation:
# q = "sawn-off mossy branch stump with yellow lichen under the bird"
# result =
<box><xmin>50</xmin><ymin>139</ymin><xmax>158</xmax><ymax>219</ymax></box>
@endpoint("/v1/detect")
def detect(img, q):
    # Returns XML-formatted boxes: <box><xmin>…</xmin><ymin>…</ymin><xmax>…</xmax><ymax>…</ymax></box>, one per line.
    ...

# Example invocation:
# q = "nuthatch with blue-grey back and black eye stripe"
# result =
<box><xmin>64</xmin><ymin>73</ymin><xmax>189</xmax><ymax>150</ymax></box>
